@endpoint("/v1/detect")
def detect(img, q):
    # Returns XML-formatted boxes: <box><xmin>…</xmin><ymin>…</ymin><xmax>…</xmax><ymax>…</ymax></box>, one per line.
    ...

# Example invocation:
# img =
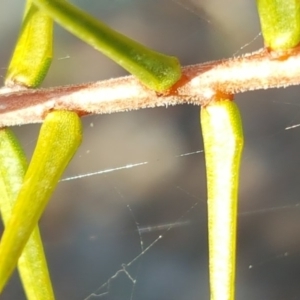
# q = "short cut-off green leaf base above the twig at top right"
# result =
<box><xmin>256</xmin><ymin>0</ymin><xmax>300</xmax><ymax>50</ymax></box>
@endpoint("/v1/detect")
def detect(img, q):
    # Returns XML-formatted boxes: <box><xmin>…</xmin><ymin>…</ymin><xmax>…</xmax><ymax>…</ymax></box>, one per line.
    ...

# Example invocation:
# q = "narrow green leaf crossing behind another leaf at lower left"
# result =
<box><xmin>0</xmin><ymin>128</ymin><xmax>54</xmax><ymax>300</ymax></box>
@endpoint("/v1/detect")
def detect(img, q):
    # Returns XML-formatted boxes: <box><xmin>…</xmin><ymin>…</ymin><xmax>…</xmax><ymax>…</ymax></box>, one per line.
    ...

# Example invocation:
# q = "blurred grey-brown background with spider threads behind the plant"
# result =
<box><xmin>0</xmin><ymin>0</ymin><xmax>300</xmax><ymax>300</ymax></box>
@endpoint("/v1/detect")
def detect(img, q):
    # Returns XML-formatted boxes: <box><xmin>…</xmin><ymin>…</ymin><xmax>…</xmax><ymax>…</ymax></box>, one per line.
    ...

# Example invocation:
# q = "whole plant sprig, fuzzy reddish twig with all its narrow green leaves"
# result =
<box><xmin>0</xmin><ymin>0</ymin><xmax>300</xmax><ymax>300</ymax></box>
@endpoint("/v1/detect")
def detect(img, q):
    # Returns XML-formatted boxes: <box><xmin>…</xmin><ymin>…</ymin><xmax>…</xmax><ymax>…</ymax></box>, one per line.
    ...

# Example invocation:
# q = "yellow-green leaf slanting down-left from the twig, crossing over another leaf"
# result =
<box><xmin>0</xmin><ymin>111</ymin><xmax>82</xmax><ymax>292</ymax></box>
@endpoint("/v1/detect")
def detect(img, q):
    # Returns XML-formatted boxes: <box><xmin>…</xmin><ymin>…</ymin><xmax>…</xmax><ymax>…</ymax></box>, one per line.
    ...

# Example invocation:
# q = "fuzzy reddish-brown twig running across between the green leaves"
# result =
<box><xmin>0</xmin><ymin>48</ymin><xmax>300</xmax><ymax>127</ymax></box>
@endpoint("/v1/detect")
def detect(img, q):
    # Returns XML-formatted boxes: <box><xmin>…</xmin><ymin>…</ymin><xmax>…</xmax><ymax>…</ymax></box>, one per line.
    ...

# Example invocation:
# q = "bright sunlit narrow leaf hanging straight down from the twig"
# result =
<box><xmin>201</xmin><ymin>100</ymin><xmax>243</xmax><ymax>300</ymax></box>
